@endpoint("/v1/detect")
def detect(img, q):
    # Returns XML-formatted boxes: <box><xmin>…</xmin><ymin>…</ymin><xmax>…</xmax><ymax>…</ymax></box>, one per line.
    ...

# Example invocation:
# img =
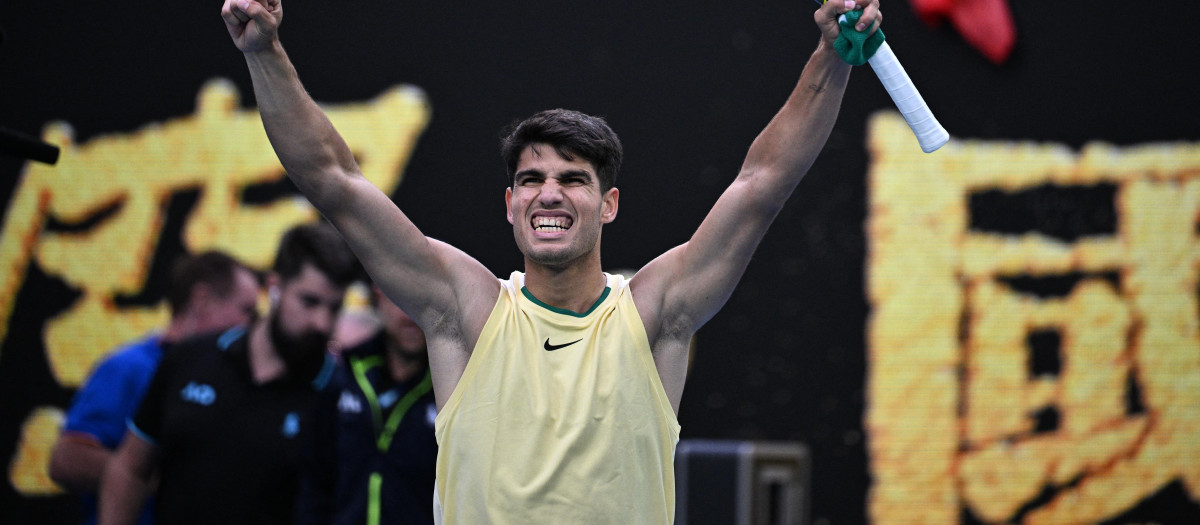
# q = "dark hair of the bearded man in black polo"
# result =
<box><xmin>271</xmin><ymin>222</ymin><xmax>361</xmax><ymax>286</ymax></box>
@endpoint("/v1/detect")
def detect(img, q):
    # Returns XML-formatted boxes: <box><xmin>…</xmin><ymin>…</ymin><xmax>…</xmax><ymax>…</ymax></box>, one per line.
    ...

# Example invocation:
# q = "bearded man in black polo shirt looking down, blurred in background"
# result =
<box><xmin>98</xmin><ymin>224</ymin><xmax>360</xmax><ymax>525</ymax></box>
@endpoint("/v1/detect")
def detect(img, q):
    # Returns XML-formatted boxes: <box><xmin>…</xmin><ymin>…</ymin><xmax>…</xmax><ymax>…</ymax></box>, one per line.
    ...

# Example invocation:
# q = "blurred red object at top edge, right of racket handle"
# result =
<box><xmin>908</xmin><ymin>0</ymin><xmax>1016</xmax><ymax>64</ymax></box>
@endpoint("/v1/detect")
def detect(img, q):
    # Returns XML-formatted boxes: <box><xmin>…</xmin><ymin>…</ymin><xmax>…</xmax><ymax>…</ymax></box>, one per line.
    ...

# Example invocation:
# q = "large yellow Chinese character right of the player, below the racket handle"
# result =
<box><xmin>865</xmin><ymin>115</ymin><xmax>1200</xmax><ymax>524</ymax></box>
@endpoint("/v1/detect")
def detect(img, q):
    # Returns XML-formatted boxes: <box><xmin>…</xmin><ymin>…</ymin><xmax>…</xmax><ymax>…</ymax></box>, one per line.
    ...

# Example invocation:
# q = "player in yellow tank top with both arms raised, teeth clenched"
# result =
<box><xmin>222</xmin><ymin>0</ymin><xmax>880</xmax><ymax>524</ymax></box>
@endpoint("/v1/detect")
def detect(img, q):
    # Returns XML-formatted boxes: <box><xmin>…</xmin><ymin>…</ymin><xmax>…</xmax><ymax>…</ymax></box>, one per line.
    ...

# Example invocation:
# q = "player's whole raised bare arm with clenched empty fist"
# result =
<box><xmin>221</xmin><ymin>0</ymin><xmax>498</xmax><ymax>381</ymax></box>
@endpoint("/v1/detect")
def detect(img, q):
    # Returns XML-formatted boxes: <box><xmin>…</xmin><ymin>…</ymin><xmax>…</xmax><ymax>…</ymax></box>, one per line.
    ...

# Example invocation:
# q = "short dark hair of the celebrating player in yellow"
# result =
<box><xmin>500</xmin><ymin>109</ymin><xmax>625</xmax><ymax>192</ymax></box>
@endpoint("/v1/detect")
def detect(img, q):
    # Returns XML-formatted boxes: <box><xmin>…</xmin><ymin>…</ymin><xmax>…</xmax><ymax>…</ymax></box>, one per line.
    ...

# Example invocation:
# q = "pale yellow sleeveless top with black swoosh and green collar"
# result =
<box><xmin>434</xmin><ymin>272</ymin><xmax>679</xmax><ymax>525</ymax></box>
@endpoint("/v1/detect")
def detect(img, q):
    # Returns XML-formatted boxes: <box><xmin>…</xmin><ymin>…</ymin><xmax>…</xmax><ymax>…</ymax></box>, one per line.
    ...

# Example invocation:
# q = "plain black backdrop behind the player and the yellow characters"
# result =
<box><xmin>0</xmin><ymin>0</ymin><xmax>1200</xmax><ymax>524</ymax></box>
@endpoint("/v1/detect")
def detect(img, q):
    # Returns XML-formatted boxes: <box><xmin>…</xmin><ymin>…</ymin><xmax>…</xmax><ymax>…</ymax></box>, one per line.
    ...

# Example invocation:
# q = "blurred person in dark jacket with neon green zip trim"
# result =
<box><xmin>296</xmin><ymin>282</ymin><xmax>438</xmax><ymax>525</ymax></box>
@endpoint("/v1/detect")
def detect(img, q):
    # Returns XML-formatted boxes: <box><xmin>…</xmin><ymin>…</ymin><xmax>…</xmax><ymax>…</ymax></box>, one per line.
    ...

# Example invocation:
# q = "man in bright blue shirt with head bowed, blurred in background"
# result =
<box><xmin>49</xmin><ymin>252</ymin><xmax>259</xmax><ymax>524</ymax></box>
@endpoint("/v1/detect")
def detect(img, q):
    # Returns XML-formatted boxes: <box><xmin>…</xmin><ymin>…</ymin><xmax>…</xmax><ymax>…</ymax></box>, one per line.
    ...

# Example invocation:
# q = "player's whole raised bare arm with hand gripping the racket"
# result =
<box><xmin>631</xmin><ymin>0</ymin><xmax>880</xmax><ymax>404</ymax></box>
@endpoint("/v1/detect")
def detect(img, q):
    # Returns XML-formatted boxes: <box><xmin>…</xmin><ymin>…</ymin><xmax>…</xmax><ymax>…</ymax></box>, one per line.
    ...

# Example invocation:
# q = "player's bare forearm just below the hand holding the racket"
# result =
<box><xmin>740</xmin><ymin>40</ymin><xmax>851</xmax><ymax>206</ymax></box>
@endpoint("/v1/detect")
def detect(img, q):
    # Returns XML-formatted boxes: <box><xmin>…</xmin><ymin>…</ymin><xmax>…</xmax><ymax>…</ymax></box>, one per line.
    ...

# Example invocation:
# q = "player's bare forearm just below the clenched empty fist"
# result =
<box><xmin>245</xmin><ymin>40</ymin><xmax>359</xmax><ymax>215</ymax></box>
